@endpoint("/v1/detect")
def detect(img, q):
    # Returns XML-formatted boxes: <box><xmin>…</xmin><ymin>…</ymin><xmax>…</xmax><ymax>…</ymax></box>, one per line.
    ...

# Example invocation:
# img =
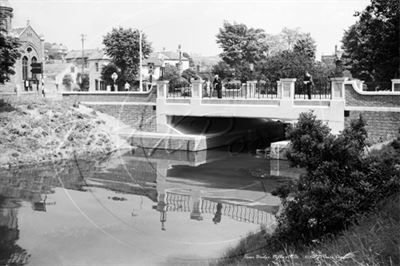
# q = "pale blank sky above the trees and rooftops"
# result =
<box><xmin>9</xmin><ymin>0</ymin><xmax>370</xmax><ymax>59</ymax></box>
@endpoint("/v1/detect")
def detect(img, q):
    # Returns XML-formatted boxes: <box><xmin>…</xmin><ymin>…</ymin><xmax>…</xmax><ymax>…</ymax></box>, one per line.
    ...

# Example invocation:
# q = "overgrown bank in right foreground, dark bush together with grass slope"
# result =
<box><xmin>218</xmin><ymin>113</ymin><xmax>400</xmax><ymax>265</ymax></box>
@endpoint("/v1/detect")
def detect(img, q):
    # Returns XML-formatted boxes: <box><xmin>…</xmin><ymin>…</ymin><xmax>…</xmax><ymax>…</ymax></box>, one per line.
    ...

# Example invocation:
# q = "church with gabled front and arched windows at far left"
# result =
<box><xmin>0</xmin><ymin>0</ymin><xmax>44</xmax><ymax>91</ymax></box>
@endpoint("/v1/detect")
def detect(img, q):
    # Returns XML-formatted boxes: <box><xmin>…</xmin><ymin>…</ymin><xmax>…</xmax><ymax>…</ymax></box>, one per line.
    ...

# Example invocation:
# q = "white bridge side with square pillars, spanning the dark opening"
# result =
<box><xmin>157</xmin><ymin>78</ymin><xmax>346</xmax><ymax>133</ymax></box>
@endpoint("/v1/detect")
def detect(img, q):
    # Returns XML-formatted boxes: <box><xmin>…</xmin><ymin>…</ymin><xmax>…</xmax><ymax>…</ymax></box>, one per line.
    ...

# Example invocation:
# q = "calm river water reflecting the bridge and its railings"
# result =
<box><xmin>0</xmin><ymin>149</ymin><xmax>296</xmax><ymax>265</ymax></box>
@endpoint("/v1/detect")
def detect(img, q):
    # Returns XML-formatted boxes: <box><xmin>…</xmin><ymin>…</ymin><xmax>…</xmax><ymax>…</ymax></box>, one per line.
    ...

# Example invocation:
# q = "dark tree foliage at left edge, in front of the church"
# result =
<box><xmin>0</xmin><ymin>29</ymin><xmax>21</xmax><ymax>84</ymax></box>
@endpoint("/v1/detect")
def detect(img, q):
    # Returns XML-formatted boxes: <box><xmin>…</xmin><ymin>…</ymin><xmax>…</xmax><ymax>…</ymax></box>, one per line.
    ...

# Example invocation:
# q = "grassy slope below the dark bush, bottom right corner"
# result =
<box><xmin>217</xmin><ymin>195</ymin><xmax>400</xmax><ymax>265</ymax></box>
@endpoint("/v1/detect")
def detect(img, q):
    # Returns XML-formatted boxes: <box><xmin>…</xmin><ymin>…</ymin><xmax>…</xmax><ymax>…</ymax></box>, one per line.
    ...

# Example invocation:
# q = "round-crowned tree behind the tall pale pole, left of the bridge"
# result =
<box><xmin>103</xmin><ymin>27</ymin><xmax>152</xmax><ymax>83</ymax></box>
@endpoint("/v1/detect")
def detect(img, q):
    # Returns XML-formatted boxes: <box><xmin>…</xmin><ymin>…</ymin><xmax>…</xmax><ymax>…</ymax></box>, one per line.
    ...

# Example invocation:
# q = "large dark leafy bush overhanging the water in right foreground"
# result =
<box><xmin>276</xmin><ymin>113</ymin><xmax>400</xmax><ymax>246</ymax></box>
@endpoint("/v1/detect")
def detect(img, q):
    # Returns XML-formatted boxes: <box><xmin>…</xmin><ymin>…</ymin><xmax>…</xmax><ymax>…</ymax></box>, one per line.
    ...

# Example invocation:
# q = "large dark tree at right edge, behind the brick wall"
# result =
<box><xmin>342</xmin><ymin>0</ymin><xmax>400</xmax><ymax>81</ymax></box>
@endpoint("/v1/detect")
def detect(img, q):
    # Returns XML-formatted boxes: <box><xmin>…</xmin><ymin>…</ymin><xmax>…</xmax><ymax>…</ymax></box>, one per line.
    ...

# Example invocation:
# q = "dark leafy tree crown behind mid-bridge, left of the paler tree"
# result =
<box><xmin>217</xmin><ymin>21</ymin><xmax>268</xmax><ymax>67</ymax></box>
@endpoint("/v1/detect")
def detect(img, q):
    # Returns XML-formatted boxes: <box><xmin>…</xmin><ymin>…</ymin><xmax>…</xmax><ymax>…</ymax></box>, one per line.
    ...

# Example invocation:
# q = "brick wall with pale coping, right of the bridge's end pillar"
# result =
<box><xmin>345</xmin><ymin>84</ymin><xmax>400</xmax><ymax>143</ymax></box>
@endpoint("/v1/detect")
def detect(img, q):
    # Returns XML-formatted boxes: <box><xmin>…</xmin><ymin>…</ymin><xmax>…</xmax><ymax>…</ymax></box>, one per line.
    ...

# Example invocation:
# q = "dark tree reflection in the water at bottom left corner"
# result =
<box><xmin>0</xmin><ymin>195</ymin><xmax>30</xmax><ymax>265</ymax></box>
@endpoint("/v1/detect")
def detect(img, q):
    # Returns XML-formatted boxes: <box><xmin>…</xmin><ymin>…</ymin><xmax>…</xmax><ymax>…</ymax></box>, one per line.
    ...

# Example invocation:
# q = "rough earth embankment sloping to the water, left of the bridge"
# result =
<box><xmin>0</xmin><ymin>99</ymin><xmax>129</xmax><ymax>168</ymax></box>
